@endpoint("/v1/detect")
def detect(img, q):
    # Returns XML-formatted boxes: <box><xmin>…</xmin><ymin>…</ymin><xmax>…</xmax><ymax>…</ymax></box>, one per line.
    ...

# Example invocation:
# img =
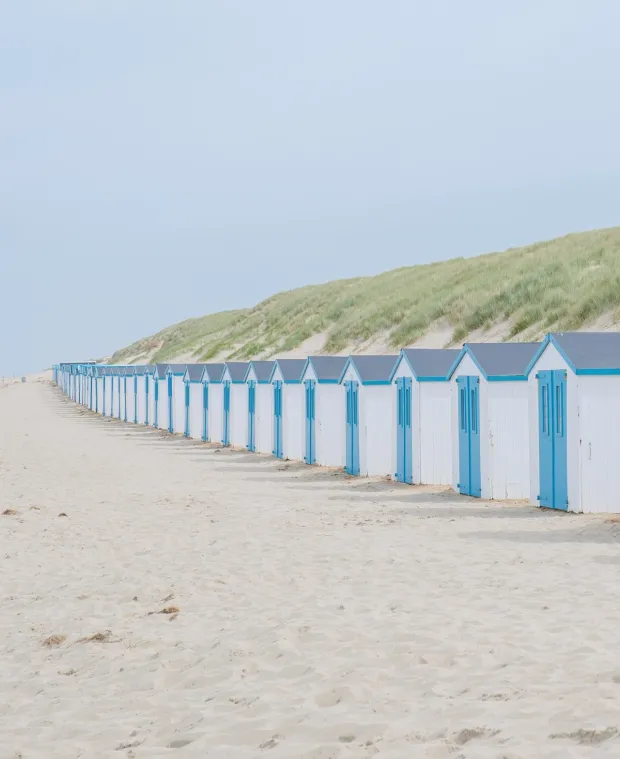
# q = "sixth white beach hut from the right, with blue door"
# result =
<box><xmin>270</xmin><ymin>358</ymin><xmax>306</xmax><ymax>461</ymax></box>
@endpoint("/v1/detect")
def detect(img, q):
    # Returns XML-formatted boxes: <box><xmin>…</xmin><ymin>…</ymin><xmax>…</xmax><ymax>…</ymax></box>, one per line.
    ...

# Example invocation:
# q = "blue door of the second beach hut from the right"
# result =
<box><xmin>456</xmin><ymin>377</ymin><xmax>482</xmax><ymax>498</ymax></box>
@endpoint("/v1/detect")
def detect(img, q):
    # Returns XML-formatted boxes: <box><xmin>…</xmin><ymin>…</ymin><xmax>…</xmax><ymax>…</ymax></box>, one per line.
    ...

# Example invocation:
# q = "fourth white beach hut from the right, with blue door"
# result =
<box><xmin>340</xmin><ymin>355</ymin><xmax>398</xmax><ymax>477</ymax></box>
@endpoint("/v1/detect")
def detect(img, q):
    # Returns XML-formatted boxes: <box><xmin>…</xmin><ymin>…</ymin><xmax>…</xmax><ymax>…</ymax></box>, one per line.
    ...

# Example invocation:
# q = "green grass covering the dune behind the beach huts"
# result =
<box><xmin>113</xmin><ymin>227</ymin><xmax>620</xmax><ymax>362</ymax></box>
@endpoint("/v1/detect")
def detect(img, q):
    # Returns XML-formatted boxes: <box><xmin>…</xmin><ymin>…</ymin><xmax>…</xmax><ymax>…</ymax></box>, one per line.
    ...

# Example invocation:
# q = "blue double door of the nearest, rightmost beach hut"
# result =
<box><xmin>536</xmin><ymin>370</ymin><xmax>568</xmax><ymax>511</ymax></box>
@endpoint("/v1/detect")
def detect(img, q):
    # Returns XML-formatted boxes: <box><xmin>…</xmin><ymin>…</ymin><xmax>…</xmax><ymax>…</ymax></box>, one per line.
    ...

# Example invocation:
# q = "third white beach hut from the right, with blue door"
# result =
<box><xmin>392</xmin><ymin>348</ymin><xmax>460</xmax><ymax>485</ymax></box>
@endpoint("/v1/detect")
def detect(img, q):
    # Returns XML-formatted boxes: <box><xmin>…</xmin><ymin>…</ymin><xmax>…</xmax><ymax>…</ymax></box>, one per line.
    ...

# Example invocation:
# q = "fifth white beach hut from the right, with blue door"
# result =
<box><xmin>301</xmin><ymin>356</ymin><xmax>347</xmax><ymax>467</ymax></box>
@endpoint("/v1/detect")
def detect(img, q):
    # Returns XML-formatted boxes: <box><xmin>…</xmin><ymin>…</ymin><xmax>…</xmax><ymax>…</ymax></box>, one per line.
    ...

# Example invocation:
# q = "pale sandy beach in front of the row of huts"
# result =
<box><xmin>0</xmin><ymin>382</ymin><xmax>620</xmax><ymax>759</ymax></box>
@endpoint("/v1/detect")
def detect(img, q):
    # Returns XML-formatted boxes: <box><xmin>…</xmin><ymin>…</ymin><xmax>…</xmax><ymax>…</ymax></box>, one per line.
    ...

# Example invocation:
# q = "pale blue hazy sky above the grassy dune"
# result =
<box><xmin>0</xmin><ymin>0</ymin><xmax>620</xmax><ymax>375</ymax></box>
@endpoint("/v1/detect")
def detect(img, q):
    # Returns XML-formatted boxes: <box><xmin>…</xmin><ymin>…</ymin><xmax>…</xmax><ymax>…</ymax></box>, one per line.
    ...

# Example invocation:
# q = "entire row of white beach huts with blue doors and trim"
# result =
<box><xmin>54</xmin><ymin>332</ymin><xmax>620</xmax><ymax>512</ymax></box>
